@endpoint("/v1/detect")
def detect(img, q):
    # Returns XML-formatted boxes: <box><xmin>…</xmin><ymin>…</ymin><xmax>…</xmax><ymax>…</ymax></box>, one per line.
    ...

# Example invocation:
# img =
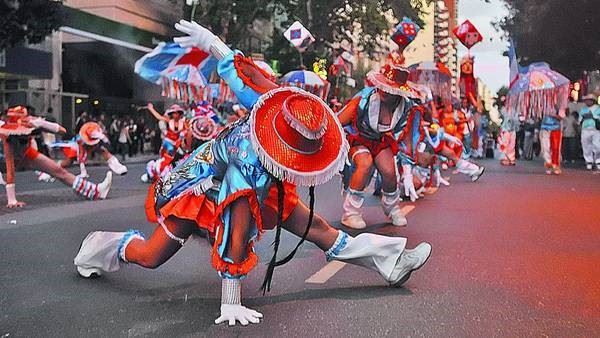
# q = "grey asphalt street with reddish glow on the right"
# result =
<box><xmin>0</xmin><ymin>161</ymin><xmax>600</xmax><ymax>338</ymax></box>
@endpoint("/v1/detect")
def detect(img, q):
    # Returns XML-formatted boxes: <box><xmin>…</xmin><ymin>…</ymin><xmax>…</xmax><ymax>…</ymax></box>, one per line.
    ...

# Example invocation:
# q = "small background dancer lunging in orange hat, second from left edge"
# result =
<box><xmin>49</xmin><ymin>122</ymin><xmax>127</xmax><ymax>180</ymax></box>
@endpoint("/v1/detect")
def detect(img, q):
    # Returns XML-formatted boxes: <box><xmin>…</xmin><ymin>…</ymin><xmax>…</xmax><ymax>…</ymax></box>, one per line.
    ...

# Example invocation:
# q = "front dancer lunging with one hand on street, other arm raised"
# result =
<box><xmin>74</xmin><ymin>20</ymin><xmax>431</xmax><ymax>325</ymax></box>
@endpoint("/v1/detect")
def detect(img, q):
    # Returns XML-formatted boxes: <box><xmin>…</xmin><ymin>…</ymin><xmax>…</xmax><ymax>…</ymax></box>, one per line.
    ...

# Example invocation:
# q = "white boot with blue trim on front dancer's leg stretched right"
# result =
<box><xmin>325</xmin><ymin>231</ymin><xmax>431</xmax><ymax>286</ymax></box>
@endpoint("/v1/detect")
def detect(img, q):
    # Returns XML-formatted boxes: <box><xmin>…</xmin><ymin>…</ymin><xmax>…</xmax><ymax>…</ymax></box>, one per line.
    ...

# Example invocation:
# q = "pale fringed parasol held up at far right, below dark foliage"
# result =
<box><xmin>506</xmin><ymin>62</ymin><xmax>570</xmax><ymax>118</ymax></box>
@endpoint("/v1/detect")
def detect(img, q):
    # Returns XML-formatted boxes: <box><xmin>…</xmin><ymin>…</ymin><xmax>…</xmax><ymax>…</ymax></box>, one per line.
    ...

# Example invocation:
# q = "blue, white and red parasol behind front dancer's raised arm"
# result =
<box><xmin>135</xmin><ymin>42</ymin><xmax>217</xmax><ymax>101</ymax></box>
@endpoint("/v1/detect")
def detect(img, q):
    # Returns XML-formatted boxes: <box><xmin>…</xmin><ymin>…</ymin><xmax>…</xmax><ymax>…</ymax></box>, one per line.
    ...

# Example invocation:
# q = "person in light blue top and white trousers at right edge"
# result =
<box><xmin>579</xmin><ymin>94</ymin><xmax>600</xmax><ymax>170</ymax></box>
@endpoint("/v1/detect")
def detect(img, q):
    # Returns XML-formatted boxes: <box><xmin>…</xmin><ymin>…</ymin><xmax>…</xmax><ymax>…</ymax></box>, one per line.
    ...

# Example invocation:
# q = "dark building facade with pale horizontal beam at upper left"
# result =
<box><xmin>0</xmin><ymin>0</ymin><xmax>184</xmax><ymax>129</ymax></box>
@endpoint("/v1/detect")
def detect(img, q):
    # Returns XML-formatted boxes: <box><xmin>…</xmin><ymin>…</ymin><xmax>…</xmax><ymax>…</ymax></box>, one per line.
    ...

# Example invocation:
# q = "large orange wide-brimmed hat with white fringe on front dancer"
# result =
<box><xmin>250</xmin><ymin>87</ymin><xmax>349</xmax><ymax>186</ymax></box>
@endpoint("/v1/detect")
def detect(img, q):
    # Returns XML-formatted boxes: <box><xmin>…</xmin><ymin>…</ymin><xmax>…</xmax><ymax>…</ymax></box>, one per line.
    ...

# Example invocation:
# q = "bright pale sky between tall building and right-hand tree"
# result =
<box><xmin>458</xmin><ymin>0</ymin><xmax>508</xmax><ymax>93</ymax></box>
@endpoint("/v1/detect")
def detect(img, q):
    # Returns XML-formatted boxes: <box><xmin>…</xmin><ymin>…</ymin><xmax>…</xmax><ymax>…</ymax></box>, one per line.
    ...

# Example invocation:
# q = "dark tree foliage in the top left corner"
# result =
<box><xmin>0</xmin><ymin>0</ymin><xmax>62</xmax><ymax>49</ymax></box>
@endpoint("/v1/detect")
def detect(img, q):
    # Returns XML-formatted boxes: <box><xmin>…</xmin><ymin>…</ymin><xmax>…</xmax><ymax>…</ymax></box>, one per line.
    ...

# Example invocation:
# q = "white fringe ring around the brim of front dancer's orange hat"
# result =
<box><xmin>249</xmin><ymin>87</ymin><xmax>350</xmax><ymax>187</ymax></box>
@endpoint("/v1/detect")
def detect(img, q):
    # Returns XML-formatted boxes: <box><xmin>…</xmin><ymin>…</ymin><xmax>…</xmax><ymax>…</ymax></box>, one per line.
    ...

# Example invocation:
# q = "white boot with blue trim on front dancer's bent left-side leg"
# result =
<box><xmin>73</xmin><ymin>230</ymin><xmax>144</xmax><ymax>278</ymax></box>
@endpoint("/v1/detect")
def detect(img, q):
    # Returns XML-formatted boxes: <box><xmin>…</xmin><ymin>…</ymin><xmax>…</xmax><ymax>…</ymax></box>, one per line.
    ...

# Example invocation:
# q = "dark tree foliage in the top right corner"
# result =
<box><xmin>498</xmin><ymin>0</ymin><xmax>600</xmax><ymax>80</ymax></box>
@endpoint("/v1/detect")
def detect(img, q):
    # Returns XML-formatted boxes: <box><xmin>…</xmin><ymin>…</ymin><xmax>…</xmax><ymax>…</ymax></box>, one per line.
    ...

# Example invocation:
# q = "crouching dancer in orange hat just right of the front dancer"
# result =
<box><xmin>338</xmin><ymin>55</ymin><xmax>420</xmax><ymax>229</ymax></box>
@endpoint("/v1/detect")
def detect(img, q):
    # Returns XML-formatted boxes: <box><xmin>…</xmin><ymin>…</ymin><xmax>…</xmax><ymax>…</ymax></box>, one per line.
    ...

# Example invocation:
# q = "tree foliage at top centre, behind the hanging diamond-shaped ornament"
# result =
<box><xmin>171</xmin><ymin>0</ymin><xmax>432</xmax><ymax>71</ymax></box>
